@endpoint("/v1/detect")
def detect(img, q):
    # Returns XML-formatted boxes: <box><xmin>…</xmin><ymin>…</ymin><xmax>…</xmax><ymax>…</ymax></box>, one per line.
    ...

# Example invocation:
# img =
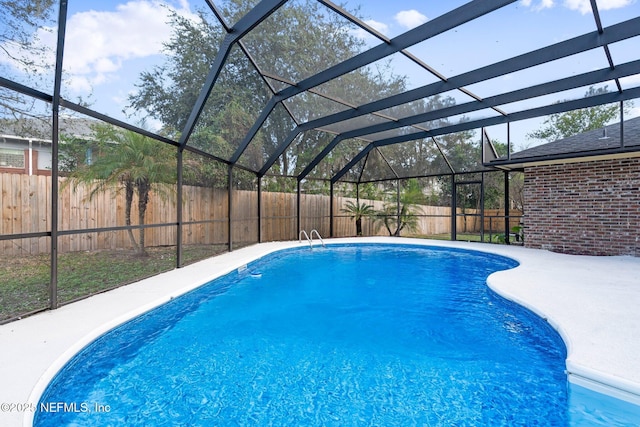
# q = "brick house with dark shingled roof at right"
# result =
<box><xmin>485</xmin><ymin>117</ymin><xmax>640</xmax><ymax>256</ymax></box>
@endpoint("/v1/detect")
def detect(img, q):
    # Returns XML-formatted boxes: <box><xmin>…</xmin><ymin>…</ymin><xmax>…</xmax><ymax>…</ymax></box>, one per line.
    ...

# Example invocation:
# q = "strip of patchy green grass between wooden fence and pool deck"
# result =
<box><xmin>0</xmin><ymin>245</ymin><xmax>226</xmax><ymax>322</ymax></box>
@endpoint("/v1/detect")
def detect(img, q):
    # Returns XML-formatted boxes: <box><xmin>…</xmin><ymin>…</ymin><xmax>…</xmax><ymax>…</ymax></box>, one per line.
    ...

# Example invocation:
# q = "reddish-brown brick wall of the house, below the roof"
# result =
<box><xmin>524</xmin><ymin>158</ymin><xmax>640</xmax><ymax>256</ymax></box>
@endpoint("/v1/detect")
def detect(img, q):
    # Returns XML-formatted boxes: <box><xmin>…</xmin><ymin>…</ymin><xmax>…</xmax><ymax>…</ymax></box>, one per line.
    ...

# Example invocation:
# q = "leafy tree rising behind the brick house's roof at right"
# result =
<box><xmin>527</xmin><ymin>86</ymin><xmax>620</xmax><ymax>142</ymax></box>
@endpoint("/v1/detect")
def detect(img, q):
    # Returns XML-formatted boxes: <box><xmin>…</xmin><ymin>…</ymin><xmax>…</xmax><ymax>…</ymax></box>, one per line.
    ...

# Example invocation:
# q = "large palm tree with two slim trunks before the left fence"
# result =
<box><xmin>69</xmin><ymin>126</ymin><xmax>176</xmax><ymax>255</ymax></box>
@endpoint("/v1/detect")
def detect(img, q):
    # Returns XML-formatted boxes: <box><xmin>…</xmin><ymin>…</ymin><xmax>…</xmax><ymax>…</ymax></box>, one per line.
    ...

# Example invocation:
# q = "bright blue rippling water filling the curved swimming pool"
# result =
<box><xmin>34</xmin><ymin>245</ymin><xmax>636</xmax><ymax>426</ymax></box>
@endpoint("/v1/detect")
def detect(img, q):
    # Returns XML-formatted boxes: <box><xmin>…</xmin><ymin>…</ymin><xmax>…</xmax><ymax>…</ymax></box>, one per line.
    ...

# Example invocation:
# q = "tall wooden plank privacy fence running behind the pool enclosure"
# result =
<box><xmin>0</xmin><ymin>174</ymin><xmax>519</xmax><ymax>255</ymax></box>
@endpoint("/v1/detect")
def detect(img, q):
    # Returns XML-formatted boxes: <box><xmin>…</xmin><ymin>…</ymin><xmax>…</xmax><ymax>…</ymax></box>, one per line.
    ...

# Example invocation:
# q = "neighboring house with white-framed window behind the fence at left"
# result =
<box><xmin>0</xmin><ymin>118</ymin><xmax>95</xmax><ymax>175</ymax></box>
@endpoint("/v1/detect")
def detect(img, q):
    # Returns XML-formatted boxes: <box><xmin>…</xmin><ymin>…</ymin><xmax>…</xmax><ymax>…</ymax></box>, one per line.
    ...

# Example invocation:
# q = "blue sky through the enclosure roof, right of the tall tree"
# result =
<box><xmin>347</xmin><ymin>0</ymin><xmax>640</xmax><ymax>145</ymax></box>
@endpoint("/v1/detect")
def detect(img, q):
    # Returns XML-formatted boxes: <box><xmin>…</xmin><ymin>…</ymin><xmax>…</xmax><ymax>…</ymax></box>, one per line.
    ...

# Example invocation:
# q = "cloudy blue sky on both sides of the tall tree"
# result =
<box><xmin>0</xmin><ymin>0</ymin><xmax>640</xmax><ymax>149</ymax></box>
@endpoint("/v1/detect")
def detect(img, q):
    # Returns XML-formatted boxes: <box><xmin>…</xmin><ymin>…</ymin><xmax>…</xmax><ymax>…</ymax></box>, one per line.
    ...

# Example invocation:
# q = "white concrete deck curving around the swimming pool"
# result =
<box><xmin>0</xmin><ymin>237</ymin><xmax>640</xmax><ymax>426</ymax></box>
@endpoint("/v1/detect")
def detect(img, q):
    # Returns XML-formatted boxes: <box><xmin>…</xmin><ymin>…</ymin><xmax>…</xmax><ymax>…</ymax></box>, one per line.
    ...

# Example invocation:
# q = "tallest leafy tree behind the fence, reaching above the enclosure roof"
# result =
<box><xmin>129</xmin><ymin>0</ymin><xmax>405</xmax><ymax>182</ymax></box>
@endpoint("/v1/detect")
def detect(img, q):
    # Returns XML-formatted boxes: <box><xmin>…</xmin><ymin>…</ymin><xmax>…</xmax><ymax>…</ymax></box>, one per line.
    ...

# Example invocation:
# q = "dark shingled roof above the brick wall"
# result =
<box><xmin>488</xmin><ymin>117</ymin><xmax>640</xmax><ymax>169</ymax></box>
